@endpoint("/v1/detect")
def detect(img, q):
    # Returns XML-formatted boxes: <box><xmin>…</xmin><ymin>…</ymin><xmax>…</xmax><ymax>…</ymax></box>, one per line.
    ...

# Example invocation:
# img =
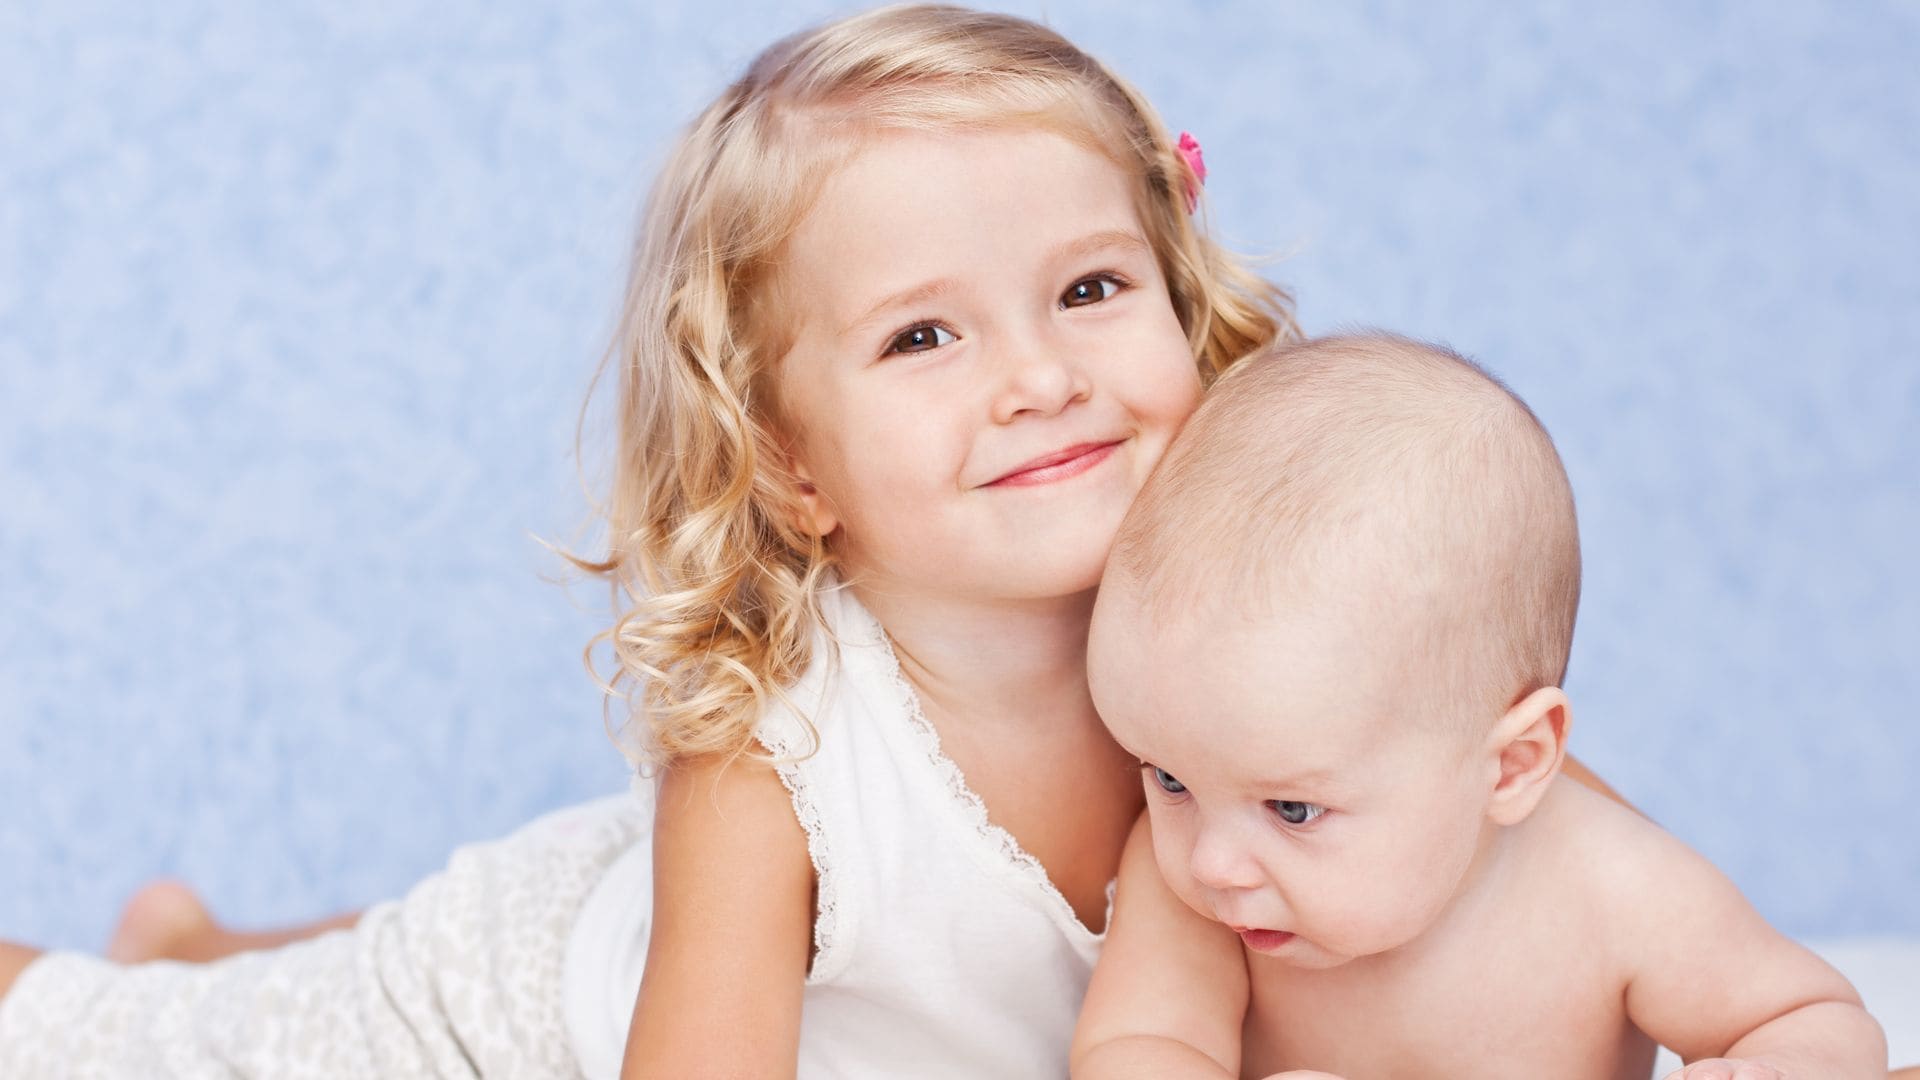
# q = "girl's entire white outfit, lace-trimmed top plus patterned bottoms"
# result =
<box><xmin>0</xmin><ymin>590</ymin><xmax>1100</xmax><ymax>1080</ymax></box>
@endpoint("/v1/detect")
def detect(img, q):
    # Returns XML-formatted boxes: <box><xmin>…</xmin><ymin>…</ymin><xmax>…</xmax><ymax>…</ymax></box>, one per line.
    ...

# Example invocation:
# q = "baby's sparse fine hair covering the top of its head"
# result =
<box><xmin>1102</xmin><ymin>334</ymin><xmax>1580</xmax><ymax>719</ymax></box>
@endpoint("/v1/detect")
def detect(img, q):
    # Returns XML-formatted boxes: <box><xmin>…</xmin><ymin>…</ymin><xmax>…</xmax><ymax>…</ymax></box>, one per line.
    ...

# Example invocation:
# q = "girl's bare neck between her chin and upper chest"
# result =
<box><xmin>852</xmin><ymin>584</ymin><xmax>1098</xmax><ymax>724</ymax></box>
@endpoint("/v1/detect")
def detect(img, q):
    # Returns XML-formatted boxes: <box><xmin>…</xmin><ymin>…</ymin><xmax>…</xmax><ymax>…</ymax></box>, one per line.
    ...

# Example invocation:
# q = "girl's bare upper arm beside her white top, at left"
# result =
<box><xmin>620</xmin><ymin>757</ymin><xmax>814</xmax><ymax>1080</ymax></box>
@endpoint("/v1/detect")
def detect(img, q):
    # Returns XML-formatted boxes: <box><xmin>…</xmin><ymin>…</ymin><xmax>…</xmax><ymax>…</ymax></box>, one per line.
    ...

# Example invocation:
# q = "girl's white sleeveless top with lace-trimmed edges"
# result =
<box><xmin>564</xmin><ymin>588</ymin><xmax>1100</xmax><ymax>1080</ymax></box>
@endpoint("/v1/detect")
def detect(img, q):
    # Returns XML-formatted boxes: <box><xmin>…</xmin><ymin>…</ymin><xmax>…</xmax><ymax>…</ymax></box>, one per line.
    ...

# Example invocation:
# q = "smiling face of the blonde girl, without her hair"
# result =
<box><xmin>780</xmin><ymin>129</ymin><xmax>1200</xmax><ymax>598</ymax></box>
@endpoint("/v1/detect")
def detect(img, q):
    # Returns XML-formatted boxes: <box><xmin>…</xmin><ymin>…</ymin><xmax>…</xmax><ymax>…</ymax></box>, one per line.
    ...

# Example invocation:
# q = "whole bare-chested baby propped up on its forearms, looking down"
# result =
<box><xmin>1073</xmin><ymin>336</ymin><xmax>1887</xmax><ymax>1080</ymax></box>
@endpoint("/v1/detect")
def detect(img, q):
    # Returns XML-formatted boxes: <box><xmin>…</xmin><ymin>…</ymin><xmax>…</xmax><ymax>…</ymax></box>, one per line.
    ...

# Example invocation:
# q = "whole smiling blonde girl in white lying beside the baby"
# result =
<box><xmin>0</xmin><ymin>6</ymin><xmax>1620</xmax><ymax>1076</ymax></box>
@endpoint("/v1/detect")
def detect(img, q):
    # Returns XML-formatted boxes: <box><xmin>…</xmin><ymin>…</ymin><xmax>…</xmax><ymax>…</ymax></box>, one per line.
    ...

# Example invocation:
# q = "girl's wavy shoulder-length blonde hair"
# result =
<box><xmin>582</xmin><ymin>6</ymin><xmax>1298</xmax><ymax>763</ymax></box>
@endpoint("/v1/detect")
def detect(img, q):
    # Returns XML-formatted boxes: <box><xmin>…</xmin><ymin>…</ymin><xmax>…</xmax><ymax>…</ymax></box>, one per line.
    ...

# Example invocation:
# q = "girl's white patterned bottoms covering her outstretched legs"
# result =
<box><xmin>0</xmin><ymin>796</ymin><xmax>645</xmax><ymax>1080</ymax></box>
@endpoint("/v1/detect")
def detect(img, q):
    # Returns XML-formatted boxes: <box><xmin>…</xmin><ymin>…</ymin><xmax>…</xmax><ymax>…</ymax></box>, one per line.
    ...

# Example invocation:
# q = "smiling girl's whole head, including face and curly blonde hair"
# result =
<box><xmin>603</xmin><ymin>6</ymin><xmax>1294</xmax><ymax>757</ymax></box>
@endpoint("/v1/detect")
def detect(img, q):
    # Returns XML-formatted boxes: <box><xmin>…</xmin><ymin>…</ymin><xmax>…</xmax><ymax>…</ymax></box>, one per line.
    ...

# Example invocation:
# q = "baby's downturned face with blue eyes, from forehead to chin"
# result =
<box><xmin>1089</xmin><ymin>578</ymin><xmax>1498</xmax><ymax>967</ymax></box>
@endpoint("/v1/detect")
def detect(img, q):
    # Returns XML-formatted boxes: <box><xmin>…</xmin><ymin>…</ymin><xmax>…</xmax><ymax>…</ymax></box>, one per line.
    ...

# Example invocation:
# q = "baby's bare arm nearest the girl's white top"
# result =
<box><xmin>1073</xmin><ymin>813</ymin><xmax>1246</xmax><ymax>1080</ymax></box>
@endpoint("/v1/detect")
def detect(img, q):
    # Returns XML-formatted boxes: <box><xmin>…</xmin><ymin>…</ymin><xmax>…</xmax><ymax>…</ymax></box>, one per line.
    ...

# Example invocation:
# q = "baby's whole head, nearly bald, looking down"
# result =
<box><xmin>1089</xmin><ymin>336</ymin><xmax>1580</xmax><ymax>967</ymax></box>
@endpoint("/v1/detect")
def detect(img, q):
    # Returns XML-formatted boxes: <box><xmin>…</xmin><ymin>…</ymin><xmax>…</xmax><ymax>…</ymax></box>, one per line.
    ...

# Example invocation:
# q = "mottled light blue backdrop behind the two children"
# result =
<box><xmin>0</xmin><ymin>0</ymin><xmax>1920</xmax><ymax>945</ymax></box>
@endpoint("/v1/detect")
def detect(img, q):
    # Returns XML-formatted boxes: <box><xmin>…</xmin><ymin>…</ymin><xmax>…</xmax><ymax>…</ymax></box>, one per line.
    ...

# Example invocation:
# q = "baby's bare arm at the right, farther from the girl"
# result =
<box><xmin>1613</xmin><ymin>810</ymin><xmax>1887</xmax><ymax>1080</ymax></box>
